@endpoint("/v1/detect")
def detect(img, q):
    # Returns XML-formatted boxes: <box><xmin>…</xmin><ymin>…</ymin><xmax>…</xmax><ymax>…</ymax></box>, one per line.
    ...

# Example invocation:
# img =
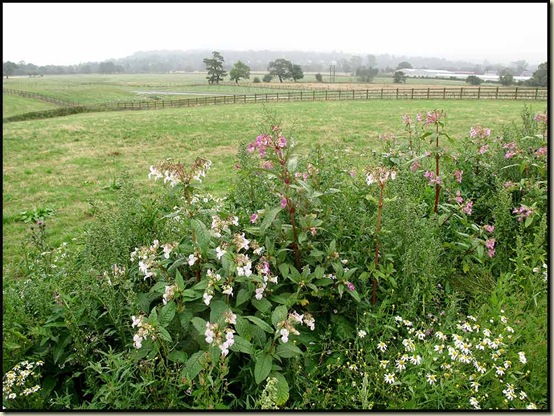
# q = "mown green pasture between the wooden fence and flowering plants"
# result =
<box><xmin>3</xmin><ymin>100</ymin><xmax>544</xmax><ymax>271</ymax></box>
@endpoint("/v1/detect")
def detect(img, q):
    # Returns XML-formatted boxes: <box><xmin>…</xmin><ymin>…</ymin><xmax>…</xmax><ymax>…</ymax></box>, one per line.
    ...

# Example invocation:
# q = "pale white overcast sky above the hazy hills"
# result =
<box><xmin>2</xmin><ymin>2</ymin><xmax>550</xmax><ymax>65</ymax></box>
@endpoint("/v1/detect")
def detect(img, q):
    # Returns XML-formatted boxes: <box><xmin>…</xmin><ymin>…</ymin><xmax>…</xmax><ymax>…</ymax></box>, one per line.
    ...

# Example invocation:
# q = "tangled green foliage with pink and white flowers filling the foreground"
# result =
<box><xmin>3</xmin><ymin>107</ymin><xmax>549</xmax><ymax>411</ymax></box>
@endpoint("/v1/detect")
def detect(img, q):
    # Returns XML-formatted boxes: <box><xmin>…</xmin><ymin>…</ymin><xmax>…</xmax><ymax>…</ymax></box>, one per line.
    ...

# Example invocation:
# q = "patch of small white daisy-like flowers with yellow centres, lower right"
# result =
<box><xmin>376</xmin><ymin>310</ymin><xmax>536</xmax><ymax>408</ymax></box>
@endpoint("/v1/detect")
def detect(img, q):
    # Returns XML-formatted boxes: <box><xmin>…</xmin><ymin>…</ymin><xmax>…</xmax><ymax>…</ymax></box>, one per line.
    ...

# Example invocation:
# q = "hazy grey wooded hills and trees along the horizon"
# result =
<box><xmin>2</xmin><ymin>50</ymin><xmax>548</xmax><ymax>86</ymax></box>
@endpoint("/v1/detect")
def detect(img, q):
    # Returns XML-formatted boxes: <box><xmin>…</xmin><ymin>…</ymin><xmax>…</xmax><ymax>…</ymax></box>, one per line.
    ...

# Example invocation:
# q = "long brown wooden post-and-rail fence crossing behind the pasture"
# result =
<box><xmin>3</xmin><ymin>87</ymin><xmax>548</xmax><ymax>121</ymax></box>
